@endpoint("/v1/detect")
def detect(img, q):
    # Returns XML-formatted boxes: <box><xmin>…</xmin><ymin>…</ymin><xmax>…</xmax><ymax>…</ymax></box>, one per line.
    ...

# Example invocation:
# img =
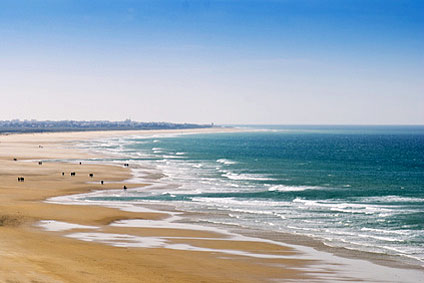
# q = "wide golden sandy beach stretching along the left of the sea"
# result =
<box><xmin>0</xmin><ymin>129</ymin><xmax>422</xmax><ymax>282</ymax></box>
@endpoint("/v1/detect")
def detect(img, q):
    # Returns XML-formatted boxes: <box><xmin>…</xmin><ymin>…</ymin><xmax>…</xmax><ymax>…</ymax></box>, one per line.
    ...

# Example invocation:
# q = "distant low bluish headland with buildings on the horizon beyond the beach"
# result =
<box><xmin>0</xmin><ymin>119</ymin><xmax>215</xmax><ymax>134</ymax></box>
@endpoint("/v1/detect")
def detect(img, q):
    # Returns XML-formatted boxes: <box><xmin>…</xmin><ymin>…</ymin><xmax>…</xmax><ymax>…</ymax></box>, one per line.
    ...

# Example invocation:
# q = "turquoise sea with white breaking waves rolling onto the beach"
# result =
<box><xmin>78</xmin><ymin>126</ymin><xmax>424</xmax><ymax>265</ymax></box>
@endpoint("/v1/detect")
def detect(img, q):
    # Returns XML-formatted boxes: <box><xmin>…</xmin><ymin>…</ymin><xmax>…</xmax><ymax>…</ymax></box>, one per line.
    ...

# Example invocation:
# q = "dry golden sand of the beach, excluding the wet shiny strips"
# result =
<box><xmin>0</xmin><ymin>129</ymin><xmax>307</xmax><ymax>282</ymax></box>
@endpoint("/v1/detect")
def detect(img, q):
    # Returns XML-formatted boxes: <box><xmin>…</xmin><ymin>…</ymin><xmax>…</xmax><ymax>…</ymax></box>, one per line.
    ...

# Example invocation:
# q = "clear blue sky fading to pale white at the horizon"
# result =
<box><xmin>0</xmin><ymin>0</ymin><xmax>424</xmax><ymax>124</ymax></box>
